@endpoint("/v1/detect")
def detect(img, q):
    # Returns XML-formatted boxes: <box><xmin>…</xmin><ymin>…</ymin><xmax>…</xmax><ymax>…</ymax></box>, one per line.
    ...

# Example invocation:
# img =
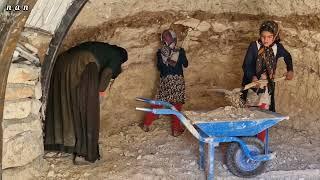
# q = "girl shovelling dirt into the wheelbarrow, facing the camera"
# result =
<box><xmin>242</xmin><ymin>21</ymin><xmax>293</xmax><ymax>140</ymax></box>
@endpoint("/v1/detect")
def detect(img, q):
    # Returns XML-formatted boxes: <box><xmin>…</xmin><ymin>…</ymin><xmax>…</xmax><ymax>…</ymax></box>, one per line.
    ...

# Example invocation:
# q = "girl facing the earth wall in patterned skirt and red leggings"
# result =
<box><xmin>143</xmin><ymin>30</ymin><xmax>188</xmax><ymax>136</ymax></box>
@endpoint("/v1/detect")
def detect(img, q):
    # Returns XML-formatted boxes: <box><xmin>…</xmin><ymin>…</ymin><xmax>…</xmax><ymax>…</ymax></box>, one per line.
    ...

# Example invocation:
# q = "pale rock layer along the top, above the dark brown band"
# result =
<box><xmin>70</xmin><ymin>0</ymin><xmax>320</xmax><ymax>26</ymax></box>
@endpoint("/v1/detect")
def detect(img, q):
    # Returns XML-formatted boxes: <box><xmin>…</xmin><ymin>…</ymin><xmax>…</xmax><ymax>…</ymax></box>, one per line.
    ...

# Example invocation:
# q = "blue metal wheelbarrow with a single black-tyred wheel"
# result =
<box><xmin>136</xmin><ymin>98</ymin><xmax>289</xmax><ymax>179</ymax></box>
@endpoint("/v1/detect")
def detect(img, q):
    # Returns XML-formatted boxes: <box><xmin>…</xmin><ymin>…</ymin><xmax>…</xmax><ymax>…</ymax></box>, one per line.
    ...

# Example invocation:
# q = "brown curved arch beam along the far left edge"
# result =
<box><xmin>0</xmin><ymin>0</ymin><xmax>37</xmax><ymax>175</ymax></box>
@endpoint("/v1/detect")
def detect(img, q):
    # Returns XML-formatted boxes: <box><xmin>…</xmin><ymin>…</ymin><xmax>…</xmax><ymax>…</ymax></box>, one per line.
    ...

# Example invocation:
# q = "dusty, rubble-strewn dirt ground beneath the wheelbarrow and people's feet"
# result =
<box><xmin>43</xmin><ymin>114</ymin><xmax>320</xmax><ymax>180</ymax></box>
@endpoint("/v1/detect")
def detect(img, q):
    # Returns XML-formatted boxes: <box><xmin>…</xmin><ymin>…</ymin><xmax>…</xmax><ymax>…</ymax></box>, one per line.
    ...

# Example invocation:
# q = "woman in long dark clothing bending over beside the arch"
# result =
<box><xmin>44</xmin><ymin>42</ymin><xmax>128</xmax><ymax>164</ymax></box>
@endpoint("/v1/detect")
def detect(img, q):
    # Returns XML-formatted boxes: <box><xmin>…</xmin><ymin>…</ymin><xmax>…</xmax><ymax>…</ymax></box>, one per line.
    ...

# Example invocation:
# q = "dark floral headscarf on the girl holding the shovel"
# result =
<box><xmin>256</xmin><ymin>21</ymin><xmax>280</xmax><ymax>78</ymax></box>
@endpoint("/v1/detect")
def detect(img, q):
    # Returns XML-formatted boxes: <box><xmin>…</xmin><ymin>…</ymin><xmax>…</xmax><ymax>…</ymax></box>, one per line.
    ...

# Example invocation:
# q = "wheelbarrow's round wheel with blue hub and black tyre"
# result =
<box><xmin>226</xmin><ymin>137</ymin><xmax>267</xmax><ymax>178</ymax></box>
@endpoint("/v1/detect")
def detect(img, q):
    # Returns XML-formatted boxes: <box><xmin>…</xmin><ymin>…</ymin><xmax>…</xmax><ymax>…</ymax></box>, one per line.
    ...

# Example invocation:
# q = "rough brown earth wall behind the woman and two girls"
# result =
<box><xmin>57</xmin><ymin>0</ymin><xmax>320</xmax><ymax>133</ymax></box>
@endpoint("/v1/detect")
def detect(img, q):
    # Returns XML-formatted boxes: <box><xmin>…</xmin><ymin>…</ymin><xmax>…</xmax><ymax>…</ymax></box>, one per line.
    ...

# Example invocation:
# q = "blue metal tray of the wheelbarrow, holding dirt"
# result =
<box><xmin>184</xmin><ymin>108</ymin><xmax>289</xmax><ymax>137</ymax></box>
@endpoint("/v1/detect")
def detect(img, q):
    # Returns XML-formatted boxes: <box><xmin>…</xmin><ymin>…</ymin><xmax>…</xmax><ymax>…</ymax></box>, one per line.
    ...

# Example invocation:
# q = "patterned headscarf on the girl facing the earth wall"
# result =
<box><xmin>160</xmin><ymin>30</ymin><xmax>179</xmax><ymax>66</ymax></box>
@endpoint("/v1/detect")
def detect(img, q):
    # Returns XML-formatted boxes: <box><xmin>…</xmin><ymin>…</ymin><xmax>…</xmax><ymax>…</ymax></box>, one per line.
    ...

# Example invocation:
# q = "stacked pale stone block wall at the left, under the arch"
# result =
<box><xmin>2</xmin><ymin>32</ymin><xmax>48</xmax><ymax>179</ymax></box>
